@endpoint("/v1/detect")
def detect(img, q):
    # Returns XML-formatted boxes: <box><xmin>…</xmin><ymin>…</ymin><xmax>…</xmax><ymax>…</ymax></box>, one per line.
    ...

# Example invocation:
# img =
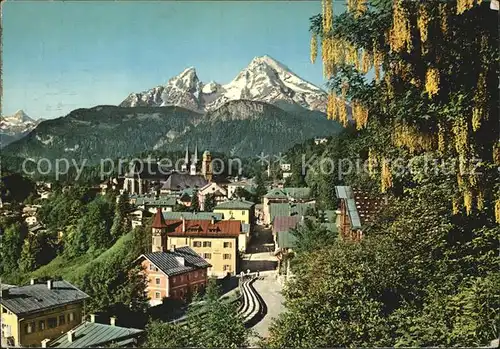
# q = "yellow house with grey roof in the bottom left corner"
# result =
<box><xmin>0</xmin><ymin>280</ymin><xmax>89</xmax><ymax>347</ymax></box>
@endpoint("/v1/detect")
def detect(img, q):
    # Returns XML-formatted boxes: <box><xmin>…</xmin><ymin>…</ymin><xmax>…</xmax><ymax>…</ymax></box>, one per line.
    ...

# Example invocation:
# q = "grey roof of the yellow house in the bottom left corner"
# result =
<box><xmin>0</xmin><ymin>281</ymin><xmax>89</xmax><ymax>315</ymax></box>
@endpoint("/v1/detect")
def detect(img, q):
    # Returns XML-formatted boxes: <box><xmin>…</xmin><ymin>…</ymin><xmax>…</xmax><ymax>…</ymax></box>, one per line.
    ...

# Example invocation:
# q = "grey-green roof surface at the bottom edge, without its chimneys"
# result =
<box><xmin>49</xmin><ymin>321</ymin><xmax>144</xmax><ymax>348</ymax></box>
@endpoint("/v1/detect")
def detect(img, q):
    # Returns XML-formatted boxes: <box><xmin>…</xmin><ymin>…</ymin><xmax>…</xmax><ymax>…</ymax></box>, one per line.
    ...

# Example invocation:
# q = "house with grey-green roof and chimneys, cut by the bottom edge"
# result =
<box><xmin>47</xmin><ymin>314</ymin><xmax>144</xmax><ymax>348</ymax></box>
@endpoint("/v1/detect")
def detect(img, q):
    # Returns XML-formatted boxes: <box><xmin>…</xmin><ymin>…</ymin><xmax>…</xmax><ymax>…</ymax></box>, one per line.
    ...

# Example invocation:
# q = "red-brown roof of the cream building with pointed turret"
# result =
<box><xmin>166</xmin><ymin>219</ymin><xmax>241</xmax><ymax>238</ymax></box>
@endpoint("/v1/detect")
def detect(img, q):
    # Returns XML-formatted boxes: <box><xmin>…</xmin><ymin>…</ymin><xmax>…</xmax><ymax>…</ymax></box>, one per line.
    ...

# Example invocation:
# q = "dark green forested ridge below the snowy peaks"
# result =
<box><xmin>3</xmin><ymin>101</ymin><xmax>339</xmax><ymax>166</ymax></box>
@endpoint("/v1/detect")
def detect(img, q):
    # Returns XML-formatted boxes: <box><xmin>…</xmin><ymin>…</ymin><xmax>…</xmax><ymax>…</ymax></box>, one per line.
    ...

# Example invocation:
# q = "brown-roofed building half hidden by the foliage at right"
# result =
<box><xmin>335</xmin><ymin>186</ymin><xmax>383</xmax><ymax>241</ymax></box>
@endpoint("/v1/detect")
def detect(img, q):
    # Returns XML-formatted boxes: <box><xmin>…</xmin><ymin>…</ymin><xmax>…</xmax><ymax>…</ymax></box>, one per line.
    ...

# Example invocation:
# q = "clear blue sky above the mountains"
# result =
<box><xmin>2</xmin><ymin>1</ymin><xmax>332</xmax><ymax>118</ymax></box>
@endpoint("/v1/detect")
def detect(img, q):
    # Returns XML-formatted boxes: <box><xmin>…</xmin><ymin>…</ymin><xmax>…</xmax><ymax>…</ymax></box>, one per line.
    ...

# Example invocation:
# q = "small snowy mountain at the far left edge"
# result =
<box><xmin>0</xmin><ymin>110</ymin><xmax>42</xmax><ymax>147</ymax></box>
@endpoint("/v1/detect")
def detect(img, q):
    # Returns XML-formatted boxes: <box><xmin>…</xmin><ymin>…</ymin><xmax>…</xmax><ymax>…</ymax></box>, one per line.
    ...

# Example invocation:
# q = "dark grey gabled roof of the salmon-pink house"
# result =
<box><xmin>141</xmin><ymin>246</ymin><xmax>212</xmax><ymax>276</ymax></box>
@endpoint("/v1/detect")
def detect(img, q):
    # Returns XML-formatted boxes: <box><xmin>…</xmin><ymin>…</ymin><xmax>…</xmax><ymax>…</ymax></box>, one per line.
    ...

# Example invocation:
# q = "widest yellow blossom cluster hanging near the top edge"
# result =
<box><xmin>389</xmin><ymin>0</ymin><xmax>411</xmax><ymax>52</ymax></box>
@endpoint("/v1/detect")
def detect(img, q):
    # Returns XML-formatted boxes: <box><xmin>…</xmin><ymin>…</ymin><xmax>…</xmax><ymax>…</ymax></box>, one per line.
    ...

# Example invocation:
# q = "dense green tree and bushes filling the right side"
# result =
<box><xmin>264</xmin><ymin>0</ymin><xmax>500</xmax><ymax>347</ymax></box>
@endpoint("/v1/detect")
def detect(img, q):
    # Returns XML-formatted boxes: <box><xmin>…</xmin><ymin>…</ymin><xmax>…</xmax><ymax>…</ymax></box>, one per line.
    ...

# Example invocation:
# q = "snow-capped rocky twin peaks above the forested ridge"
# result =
<box><xmin>121</xmin><ymin>55</ymin><xmax>327</xmax><ymax>112</ymax></box>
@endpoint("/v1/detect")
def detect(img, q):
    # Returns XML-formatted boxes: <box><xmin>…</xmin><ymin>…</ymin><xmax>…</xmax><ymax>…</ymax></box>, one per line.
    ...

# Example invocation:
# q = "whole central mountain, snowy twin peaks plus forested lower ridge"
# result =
<box><xmin>3</xmin><ymin>56</ymin><xmax>341</xmax><ymax>163</ymax></box>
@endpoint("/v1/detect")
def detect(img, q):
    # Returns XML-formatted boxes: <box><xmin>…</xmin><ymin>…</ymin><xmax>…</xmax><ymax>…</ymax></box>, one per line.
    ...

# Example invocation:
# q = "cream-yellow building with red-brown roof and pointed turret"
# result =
<box><xmin>148</xmin><ymin>207</ymin><xmax>242</xmax><ymax>277</ymax></box>
